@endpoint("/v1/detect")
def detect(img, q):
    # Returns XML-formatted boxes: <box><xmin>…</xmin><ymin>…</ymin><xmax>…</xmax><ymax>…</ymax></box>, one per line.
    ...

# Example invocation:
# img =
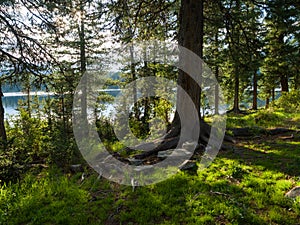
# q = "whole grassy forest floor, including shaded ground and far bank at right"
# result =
<box><xmin>0</xmin><ymin>110</ymin><xmax>300</xmax><ymax>225</ymax></box>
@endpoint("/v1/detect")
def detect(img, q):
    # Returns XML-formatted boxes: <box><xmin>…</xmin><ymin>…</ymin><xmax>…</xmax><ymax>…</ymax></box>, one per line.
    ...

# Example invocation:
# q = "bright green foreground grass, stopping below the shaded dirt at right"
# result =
<box><xmin>0</xmin><ymin>150</ymin><xmax>300</xmax><ymax>225</ymax></box>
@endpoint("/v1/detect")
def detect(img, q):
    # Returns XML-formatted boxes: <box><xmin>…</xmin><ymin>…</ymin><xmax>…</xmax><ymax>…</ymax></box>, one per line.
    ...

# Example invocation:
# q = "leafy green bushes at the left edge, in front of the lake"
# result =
<box><xmin>0</xmin><ymin>109</ymin><xmax>82</xmax><ymax>182</ymax></box>
